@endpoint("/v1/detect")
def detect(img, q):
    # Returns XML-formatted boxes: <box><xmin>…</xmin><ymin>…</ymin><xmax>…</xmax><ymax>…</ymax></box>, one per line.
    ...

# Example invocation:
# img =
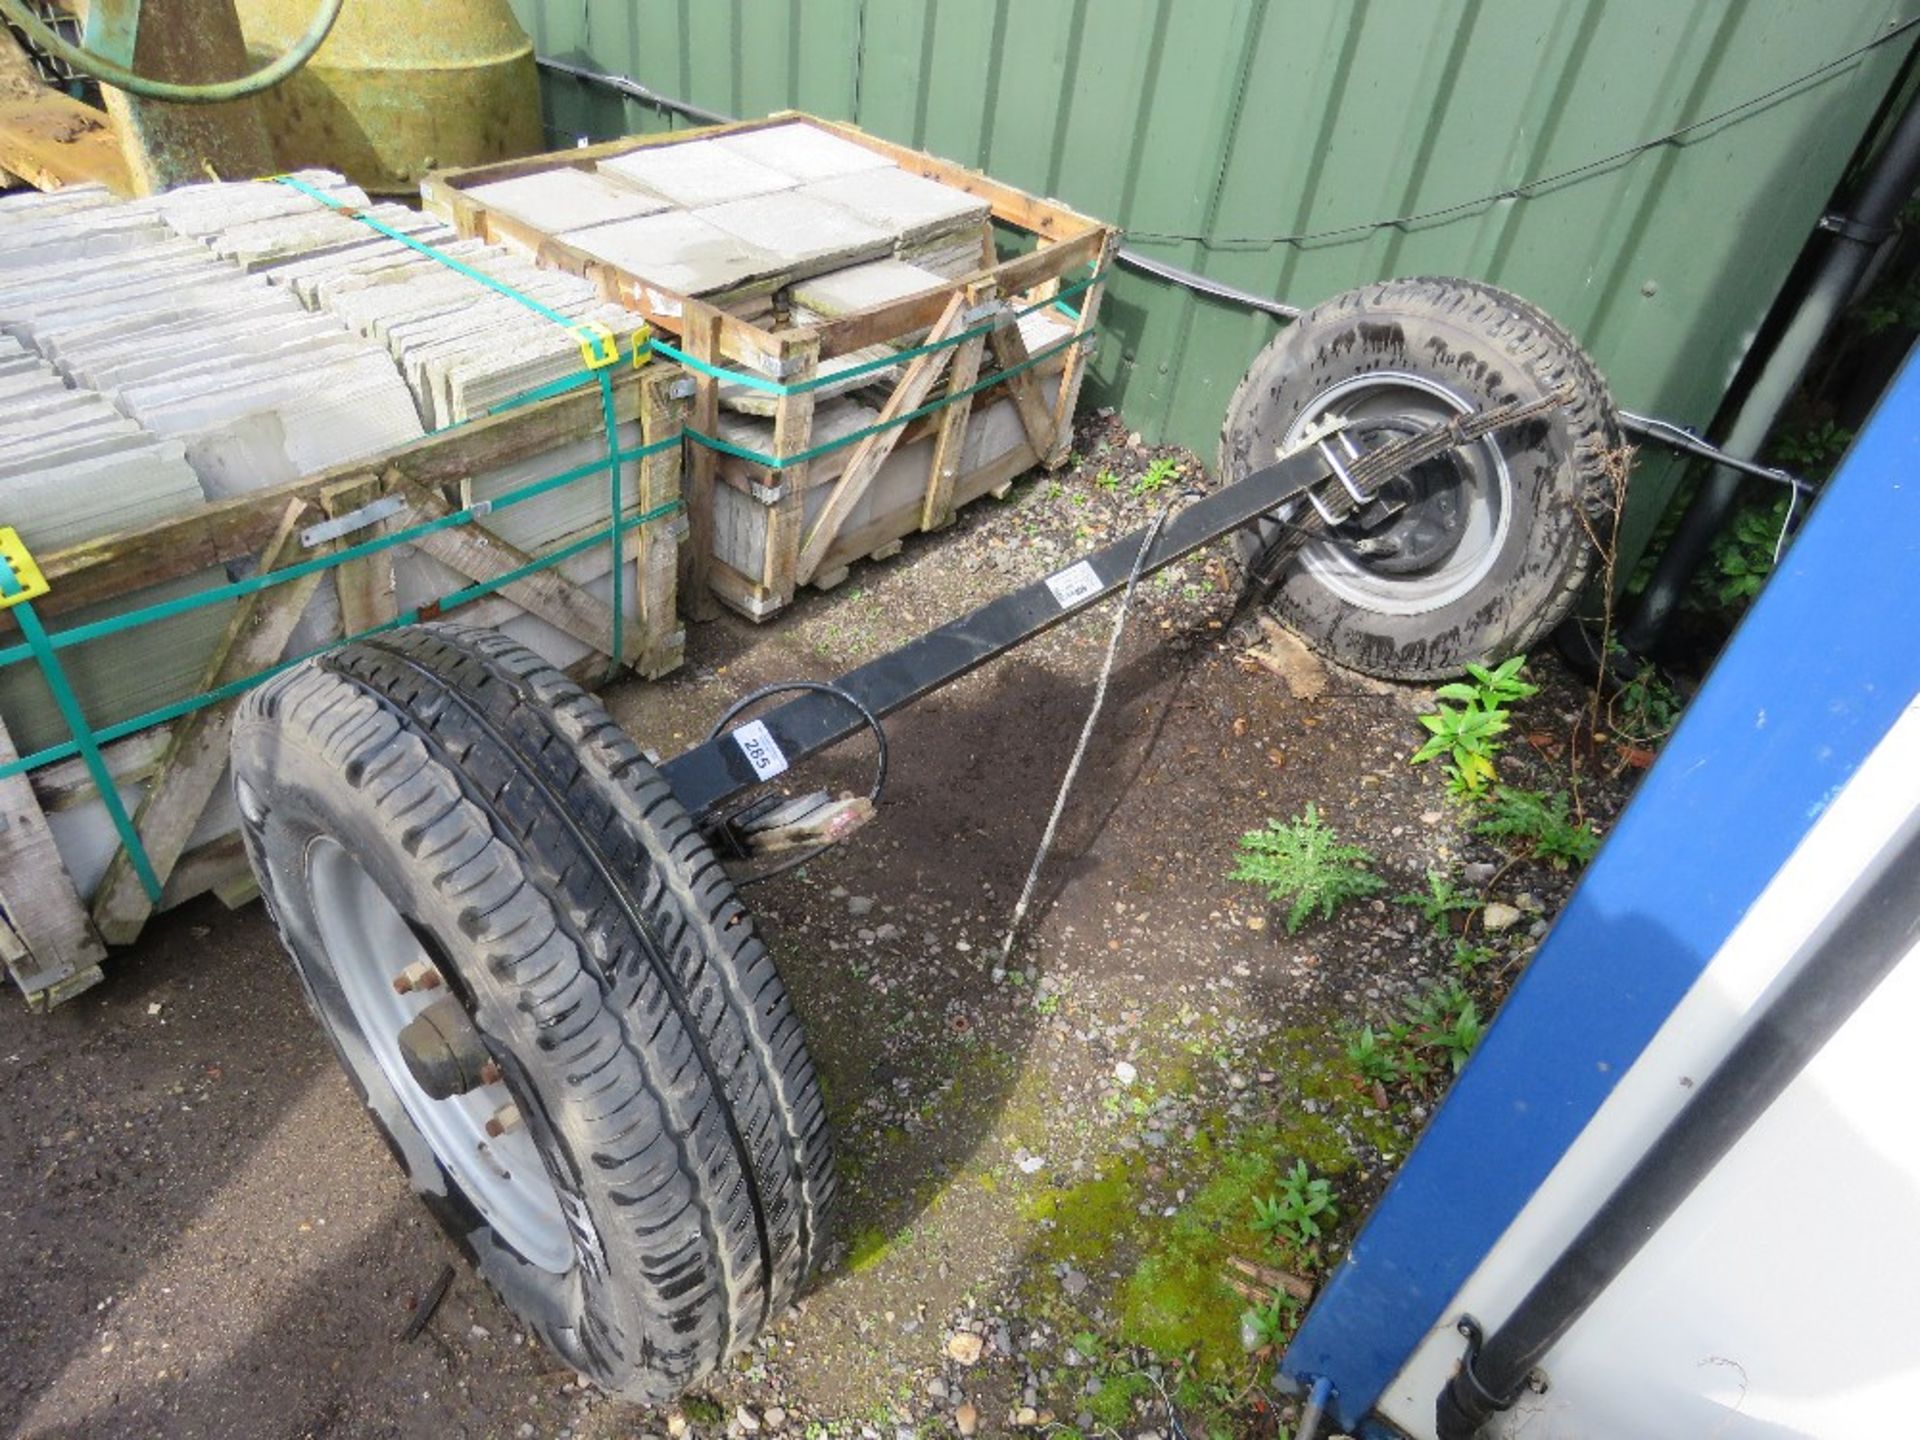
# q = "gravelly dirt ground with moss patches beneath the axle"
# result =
<box><xmin>0</xmin><ymin>410</ymin><xmax>1619</xmax><ymax>1440</ymax></box>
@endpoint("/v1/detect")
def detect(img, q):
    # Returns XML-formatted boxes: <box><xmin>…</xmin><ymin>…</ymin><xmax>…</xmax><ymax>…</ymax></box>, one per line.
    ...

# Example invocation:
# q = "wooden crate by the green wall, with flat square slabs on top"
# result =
<box><xmin>420</xmin><ymin>111</ymin><xmax>1117</xmax><ymax>618</ymax></box>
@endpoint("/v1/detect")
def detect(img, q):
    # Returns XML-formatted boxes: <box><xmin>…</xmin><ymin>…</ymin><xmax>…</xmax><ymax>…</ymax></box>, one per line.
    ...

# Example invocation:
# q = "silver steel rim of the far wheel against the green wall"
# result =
<box><xmin>1281</xmin><ymin>371</ymin><xmax>1513</xmax><ymax>614</ymax></box>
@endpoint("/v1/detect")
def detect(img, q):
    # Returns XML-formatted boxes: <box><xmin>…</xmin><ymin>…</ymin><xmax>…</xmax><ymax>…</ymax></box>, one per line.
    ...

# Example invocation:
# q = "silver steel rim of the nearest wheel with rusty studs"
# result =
<box><xmin>307</xmin><ymin>835</ymin><xmax>574</xmax><ymax>1275</ymax></box>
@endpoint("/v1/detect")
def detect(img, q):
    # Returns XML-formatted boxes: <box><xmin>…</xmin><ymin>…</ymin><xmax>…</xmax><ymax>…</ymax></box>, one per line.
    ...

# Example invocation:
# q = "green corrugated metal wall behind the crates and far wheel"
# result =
<box><xmin>515</xmin><ymin>0</ymin><xmax>1912</xmax><ymax>572</ymax></box>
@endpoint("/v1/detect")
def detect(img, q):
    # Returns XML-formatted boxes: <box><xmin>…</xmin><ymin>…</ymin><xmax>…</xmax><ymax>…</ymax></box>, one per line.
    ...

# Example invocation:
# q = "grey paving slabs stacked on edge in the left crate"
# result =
<box><xmin>0</xmin><ymin>173</ymin><xmax>675</xmax><ymax>895</ymax></box>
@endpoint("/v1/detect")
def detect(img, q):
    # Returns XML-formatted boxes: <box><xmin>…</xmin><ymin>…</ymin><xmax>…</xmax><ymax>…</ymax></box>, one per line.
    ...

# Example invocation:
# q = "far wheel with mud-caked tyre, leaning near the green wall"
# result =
<box><xmin>1219</xmin><ymin>278</ymin><xmax>1620</xmax><ymax>680</ymax></box>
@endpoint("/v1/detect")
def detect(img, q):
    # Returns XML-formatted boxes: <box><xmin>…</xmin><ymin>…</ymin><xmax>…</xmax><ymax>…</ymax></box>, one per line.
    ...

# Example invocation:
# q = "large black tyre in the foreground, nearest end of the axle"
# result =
<box><xmin>232</xmin><ymin>626</ymin><xmax>833</xmax><ymax>1402</ymax></box>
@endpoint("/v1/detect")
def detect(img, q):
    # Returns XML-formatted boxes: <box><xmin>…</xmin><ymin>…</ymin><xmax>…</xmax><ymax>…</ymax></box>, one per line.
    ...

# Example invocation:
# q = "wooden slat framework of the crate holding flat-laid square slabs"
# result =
<box><xmin>420</xmin><ymin>109</ymin><xmax>1119</xmax><ymax>618</ymax></box>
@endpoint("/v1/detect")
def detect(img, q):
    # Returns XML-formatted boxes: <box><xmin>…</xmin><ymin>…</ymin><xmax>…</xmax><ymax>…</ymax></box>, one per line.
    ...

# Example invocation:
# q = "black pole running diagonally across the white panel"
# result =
<box><xmin>1434</xmin><ymin>812</ymin><xmax>1920</xmax><ymax>1440</ymax></box>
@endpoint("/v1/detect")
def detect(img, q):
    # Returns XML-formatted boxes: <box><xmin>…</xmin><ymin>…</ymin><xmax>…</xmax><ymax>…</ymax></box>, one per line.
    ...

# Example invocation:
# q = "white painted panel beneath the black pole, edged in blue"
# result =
<box><xmin>1379</xmin><ymin>705</ymin><xmax>1920</xmax><ymax>1440</ymax></box>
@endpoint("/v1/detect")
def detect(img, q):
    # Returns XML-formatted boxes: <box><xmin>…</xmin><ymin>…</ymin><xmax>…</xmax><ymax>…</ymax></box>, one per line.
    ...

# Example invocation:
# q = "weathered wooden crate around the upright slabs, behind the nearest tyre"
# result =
<box><xmin>0</xmin><ymin>361</ymin><xmax>685</xmax><ymax>1006</ymax></box>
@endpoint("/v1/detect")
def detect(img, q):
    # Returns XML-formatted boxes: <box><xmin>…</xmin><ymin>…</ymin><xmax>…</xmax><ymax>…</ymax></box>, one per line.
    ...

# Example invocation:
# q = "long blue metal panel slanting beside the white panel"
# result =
<box><xmin>1283</xmin><ymin>343</ymin><xmax>1920</xmax><ymax>1428</ymax></box>
